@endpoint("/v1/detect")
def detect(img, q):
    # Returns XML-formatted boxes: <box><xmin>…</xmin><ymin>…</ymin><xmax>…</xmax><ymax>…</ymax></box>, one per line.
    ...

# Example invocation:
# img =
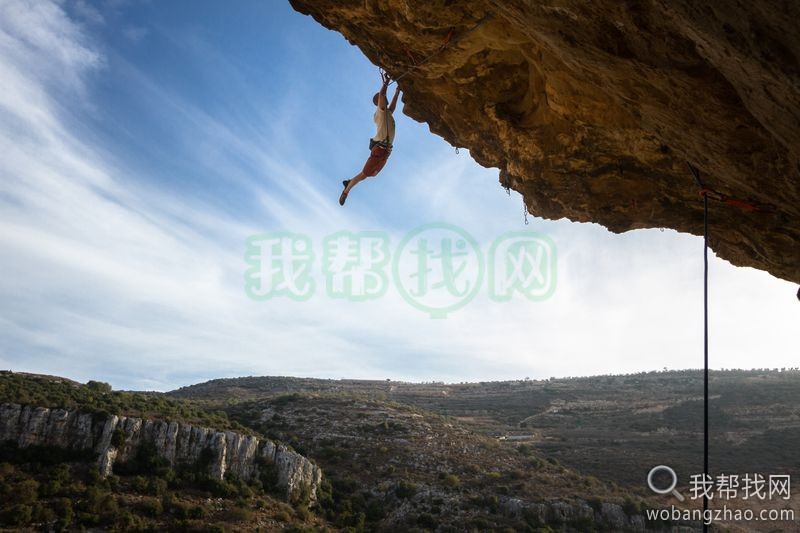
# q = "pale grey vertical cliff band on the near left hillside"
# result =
<box><xmin>0</xmin><ymin>403</ymin><xmax>322</xmax><ymax>500</ymax></box>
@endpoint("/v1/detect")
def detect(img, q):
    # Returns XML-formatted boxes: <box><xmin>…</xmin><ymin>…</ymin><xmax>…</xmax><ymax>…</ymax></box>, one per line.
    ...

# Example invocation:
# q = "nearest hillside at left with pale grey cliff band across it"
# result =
<box><xmin>0</xmin><ymin>372</ymin><xmax>330</xmax><ymax>532</ymax></box>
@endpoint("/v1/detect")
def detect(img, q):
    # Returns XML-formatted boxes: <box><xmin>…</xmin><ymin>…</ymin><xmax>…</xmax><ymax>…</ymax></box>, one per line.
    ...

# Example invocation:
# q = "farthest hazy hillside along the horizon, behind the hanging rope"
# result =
<box><xmin>169</xmin><ymin>369</ymin><xmax>800</xmax><ymax>487</ymax></box>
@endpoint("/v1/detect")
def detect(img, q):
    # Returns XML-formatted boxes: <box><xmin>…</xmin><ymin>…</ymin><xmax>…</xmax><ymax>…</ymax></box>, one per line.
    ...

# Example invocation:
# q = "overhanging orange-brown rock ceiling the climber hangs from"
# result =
<box><xmin>290</xmin><ymin>0</ymin><xmax>800</xmax><ymax>282</ymax></box>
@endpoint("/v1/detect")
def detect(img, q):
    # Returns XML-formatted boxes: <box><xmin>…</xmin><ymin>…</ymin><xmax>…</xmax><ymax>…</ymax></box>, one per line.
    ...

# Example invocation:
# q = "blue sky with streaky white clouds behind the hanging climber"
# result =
<box><xmin>0</xmin><ymin>0</ymin><xmax>800</xmax><ymax>390</ymax></box>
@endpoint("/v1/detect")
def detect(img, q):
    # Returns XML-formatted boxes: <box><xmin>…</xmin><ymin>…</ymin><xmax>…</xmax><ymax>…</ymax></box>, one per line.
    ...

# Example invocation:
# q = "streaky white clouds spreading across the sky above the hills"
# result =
<box><xmin>0</xmin><ymin>0</ymin><xmax>799</xmax><ymax>389</ymax></box>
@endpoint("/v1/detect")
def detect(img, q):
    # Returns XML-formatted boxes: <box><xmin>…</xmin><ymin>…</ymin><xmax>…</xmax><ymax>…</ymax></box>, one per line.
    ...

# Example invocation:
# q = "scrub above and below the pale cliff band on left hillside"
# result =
<box><xmin>0</xmin><ymin>372</ymin><xmax>321</xmax><ymax>531</ymax></box>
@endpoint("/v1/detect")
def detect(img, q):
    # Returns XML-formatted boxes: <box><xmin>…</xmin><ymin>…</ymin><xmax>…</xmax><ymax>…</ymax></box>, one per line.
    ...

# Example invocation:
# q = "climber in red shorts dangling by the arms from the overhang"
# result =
<box><xmin>339</xmin><ymin>71</ymin><xmax>400</xmax><ymax>205</ymax></box>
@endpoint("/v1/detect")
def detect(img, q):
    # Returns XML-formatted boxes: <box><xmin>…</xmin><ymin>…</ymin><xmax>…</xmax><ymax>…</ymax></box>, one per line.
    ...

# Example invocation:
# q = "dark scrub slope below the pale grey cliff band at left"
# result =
<box><xmin>0</xmin><ymin>443</ymin><xmax>324</xmax><ymax>531</ymax></box>
